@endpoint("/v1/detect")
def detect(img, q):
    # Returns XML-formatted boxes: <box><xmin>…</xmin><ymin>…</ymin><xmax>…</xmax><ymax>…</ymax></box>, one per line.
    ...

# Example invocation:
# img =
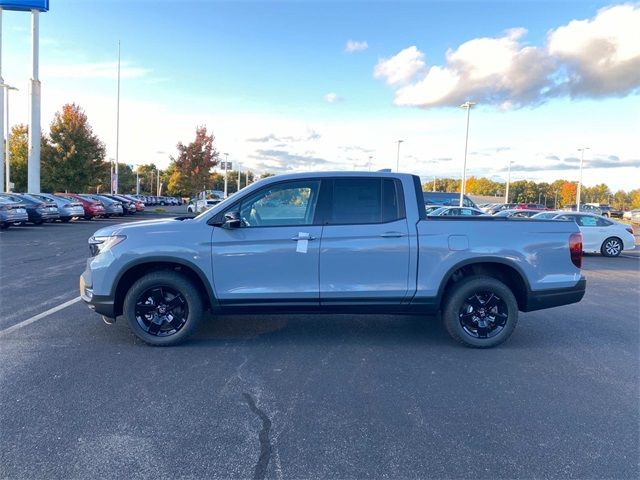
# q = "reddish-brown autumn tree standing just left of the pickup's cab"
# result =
<box><xmin>171</xmin><ymin>126</ymin><xmax>218</xmax><ymax>196</ymax></box>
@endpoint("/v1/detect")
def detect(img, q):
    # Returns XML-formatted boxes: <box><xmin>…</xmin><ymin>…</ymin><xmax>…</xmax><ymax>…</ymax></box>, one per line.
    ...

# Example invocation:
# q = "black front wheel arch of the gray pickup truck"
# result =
<box><xmin>111</xmin><ymin>257</ymin><xmax>215</xmax><ymax>315</ymax></box>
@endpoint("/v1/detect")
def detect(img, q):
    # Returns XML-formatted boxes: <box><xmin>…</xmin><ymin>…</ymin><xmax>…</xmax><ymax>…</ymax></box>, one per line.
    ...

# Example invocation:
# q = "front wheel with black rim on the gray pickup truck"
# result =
<box><xmin>123</xmin><ymin>270</ymin><xmax>203</xmax><ymax>346</ymax></box>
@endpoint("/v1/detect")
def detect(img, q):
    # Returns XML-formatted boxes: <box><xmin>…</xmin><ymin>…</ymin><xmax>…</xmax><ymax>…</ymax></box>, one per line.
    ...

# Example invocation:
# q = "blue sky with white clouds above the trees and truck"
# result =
<box><xmin>2</xmin><ymin>0</ymin><xmax>640</xmax><ymax>190</ymax></box>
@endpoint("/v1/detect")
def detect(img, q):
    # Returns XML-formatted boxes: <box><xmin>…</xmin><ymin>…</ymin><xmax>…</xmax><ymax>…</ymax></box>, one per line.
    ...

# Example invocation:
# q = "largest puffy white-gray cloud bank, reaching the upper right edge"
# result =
<box><xmin>374</xmin><ymin>4</ymin><xmax>640</xmax><ymax>109</ymax></box>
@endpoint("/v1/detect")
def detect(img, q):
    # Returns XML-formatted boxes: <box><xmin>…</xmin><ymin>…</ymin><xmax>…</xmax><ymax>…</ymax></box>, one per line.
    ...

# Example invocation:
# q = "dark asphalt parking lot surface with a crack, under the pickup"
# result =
<box><xmin>0</xmin><ymin>214</ymin><xmax>640</xmax><ymax>479</ymax></box>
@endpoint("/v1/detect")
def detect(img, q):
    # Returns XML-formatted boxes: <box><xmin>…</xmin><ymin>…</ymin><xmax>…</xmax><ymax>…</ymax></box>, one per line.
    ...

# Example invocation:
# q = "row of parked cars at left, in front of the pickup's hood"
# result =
<box><xmin>0</xmin><ymin>193</ymin><xmax>145</xmax><ymax>229</ymax></box>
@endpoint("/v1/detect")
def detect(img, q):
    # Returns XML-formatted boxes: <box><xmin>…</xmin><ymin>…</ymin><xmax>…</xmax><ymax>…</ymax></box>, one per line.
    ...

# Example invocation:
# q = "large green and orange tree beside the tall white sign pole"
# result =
<box><xmin>41</xmin><ymin>103</ymin><xmax>105</xmax><ymax>192</ymax></box>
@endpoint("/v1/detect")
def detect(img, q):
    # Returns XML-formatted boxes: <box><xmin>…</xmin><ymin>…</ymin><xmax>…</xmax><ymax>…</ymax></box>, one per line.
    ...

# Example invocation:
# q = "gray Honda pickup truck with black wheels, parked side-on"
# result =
<box><xmin>80</xmin><ymin>172</ymin><xmax>586</xmax><ymax>348</ymax></box>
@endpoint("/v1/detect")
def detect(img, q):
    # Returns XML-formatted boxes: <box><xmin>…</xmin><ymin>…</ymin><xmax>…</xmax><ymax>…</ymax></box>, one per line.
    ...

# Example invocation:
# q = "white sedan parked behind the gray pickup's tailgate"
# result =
<box><xmin>534</xmin><ymin>212</ymin><xmax>636</xmax><ymax>257</ymax></box>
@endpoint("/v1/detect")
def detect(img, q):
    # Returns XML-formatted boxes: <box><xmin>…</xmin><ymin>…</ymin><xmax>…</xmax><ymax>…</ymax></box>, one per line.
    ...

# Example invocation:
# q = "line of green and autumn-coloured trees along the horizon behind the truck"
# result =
<box><xmin>9</xmin><ymin>103</ymin><xmax>640</xmax><ymax>209</ymax></box>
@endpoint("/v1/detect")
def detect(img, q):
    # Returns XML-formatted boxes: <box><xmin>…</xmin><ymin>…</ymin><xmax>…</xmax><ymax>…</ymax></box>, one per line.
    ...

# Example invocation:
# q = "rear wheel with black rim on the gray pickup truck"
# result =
<box><xmin>442</xmin><ymin>275</ymin><xmax>518</xmax><ymax>348</ymax></box>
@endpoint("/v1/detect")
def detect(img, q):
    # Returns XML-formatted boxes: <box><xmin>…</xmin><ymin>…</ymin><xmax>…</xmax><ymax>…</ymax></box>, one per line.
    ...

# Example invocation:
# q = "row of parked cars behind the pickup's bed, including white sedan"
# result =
<box><xmin>424</xmin><ymin>192</ymin><xmax>640</xmax><ymax>257</ymax></box>
